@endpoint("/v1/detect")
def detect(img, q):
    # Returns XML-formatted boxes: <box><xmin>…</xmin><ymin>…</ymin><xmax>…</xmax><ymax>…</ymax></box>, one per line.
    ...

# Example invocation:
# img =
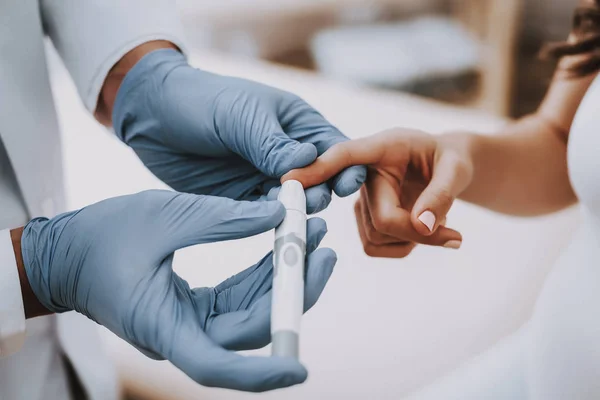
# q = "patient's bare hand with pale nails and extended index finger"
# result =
<box><xmin>282</xmin><ymin>129</ymin><xmax>473</xmax><ymax>257</ymax></box>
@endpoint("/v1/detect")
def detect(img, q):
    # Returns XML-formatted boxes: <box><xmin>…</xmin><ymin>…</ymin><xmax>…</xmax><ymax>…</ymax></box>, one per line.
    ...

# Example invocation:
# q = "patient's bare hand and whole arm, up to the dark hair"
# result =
<box><xmin>282</xmin><ymin>32</ymin><xmax>596</xmax><ymax>258</ymax></box>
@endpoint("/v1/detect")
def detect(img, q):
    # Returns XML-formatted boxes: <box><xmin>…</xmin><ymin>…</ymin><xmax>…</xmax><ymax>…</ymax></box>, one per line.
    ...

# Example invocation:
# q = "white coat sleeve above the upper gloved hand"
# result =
<box><xmin>40</xmin><ymin>0</ymin><xmax>186</xmax><ymax>112</ymax></box>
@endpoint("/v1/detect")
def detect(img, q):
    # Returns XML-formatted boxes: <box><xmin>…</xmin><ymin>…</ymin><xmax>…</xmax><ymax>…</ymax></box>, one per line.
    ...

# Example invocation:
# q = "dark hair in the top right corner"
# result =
<box><xmin>540</xmin><ymin>0</ymin><xmax>600</xmax><ymax>76</ymax></box>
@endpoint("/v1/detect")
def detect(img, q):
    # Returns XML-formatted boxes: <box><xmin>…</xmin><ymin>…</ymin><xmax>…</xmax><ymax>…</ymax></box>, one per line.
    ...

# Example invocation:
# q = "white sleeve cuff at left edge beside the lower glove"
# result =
<box><xmin>0</xmin><ymin>229</ymin><xmax>25</xmax><ymax>358</ymax></box>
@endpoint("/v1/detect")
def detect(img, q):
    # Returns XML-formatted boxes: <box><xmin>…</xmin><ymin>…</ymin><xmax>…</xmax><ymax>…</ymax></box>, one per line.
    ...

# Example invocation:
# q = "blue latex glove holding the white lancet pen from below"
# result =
<box><xmin>21</xmin><ymin>191</ymin><xmax>336</xmax><ymax>391</ymax></box>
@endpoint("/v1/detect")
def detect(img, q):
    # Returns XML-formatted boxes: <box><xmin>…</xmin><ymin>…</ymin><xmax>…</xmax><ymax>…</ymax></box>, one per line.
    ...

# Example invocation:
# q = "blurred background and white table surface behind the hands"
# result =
<box><xmin>48</xmin><ymin>0</ymin><xmax>579</xmax><ymax>400</ymax></box>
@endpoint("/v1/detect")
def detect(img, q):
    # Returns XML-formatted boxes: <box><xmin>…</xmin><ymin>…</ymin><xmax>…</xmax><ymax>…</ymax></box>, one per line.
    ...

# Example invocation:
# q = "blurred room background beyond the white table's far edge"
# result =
<box><xmin>178</xmin><ymin>0</ymin><xmax>576</xmax><ymax>117</ymax></box>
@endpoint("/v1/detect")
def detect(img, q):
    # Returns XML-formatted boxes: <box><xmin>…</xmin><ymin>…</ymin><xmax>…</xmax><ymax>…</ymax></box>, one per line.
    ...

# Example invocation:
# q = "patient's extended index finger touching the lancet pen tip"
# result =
<box><xmin>281</xmin><ymin>137</ymin><xmax>385</xmax><ymax>188</ymax></box>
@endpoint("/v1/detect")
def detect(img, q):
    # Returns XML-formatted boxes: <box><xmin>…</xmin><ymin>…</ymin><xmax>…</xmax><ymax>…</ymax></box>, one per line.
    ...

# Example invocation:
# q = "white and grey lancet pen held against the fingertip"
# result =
<box><xmin>271</xmin><ymin>180</ymin><xmax>306</xmax><ymax>358</ymax></box>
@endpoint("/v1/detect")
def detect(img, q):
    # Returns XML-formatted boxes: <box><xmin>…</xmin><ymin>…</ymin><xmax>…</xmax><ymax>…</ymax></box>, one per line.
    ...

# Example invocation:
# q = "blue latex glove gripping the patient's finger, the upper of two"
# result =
<box><xmin>112</xmin><ymin>49</ymin><xmax>366</xmax><ymax>213</ymax></box>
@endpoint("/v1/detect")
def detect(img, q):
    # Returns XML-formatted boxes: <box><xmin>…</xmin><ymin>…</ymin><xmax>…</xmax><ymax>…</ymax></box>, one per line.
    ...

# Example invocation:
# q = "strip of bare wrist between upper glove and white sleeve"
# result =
<box><xmin>94</xmin><ymin>40</ymin><xmax>178</xmax><ymax>126</ymax></box>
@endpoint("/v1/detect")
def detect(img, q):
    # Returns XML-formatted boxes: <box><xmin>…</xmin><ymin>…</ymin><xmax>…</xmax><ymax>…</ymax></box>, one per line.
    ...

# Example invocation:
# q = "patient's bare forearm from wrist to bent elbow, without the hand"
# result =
<box><xmin>450</xmin><ymin>114</ymin><xmax>577</xmax><ymax>216</ymax></box>
